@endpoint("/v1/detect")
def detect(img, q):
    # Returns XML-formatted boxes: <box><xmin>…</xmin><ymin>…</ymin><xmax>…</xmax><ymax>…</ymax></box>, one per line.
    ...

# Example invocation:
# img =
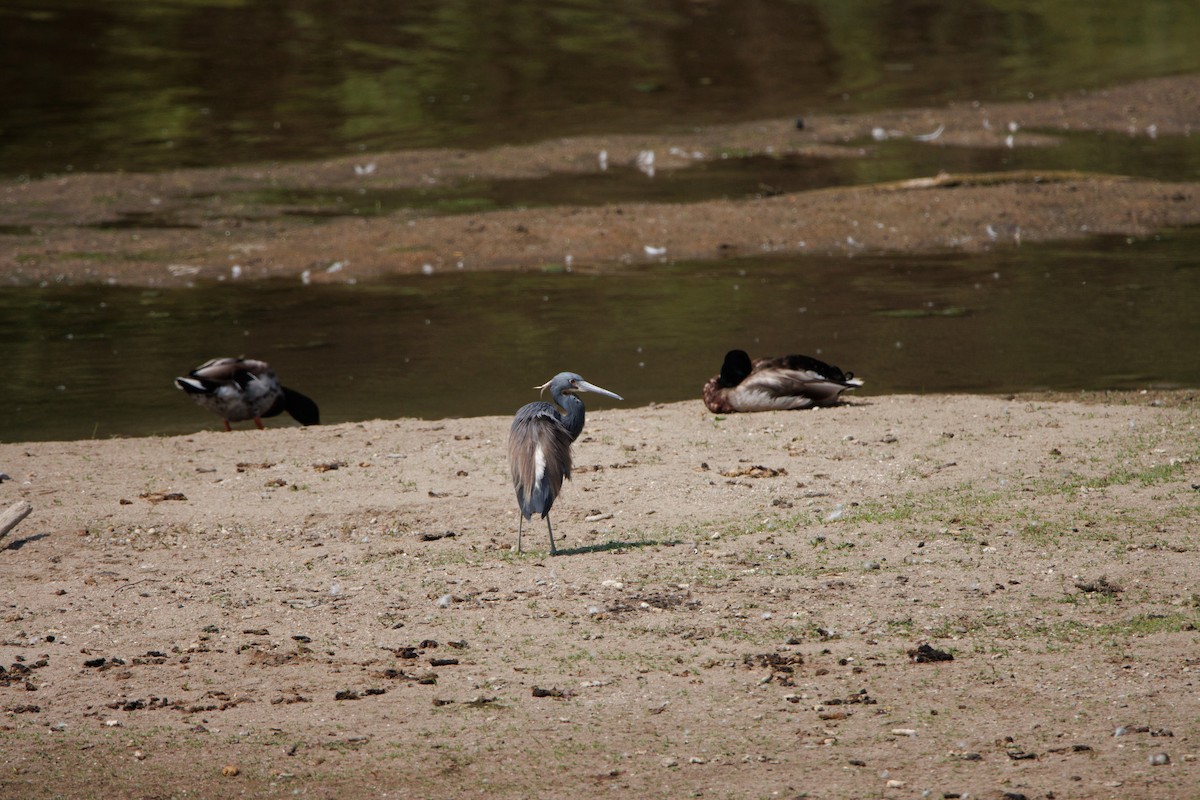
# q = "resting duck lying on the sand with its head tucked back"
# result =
<box><xmin>704</xmin><ymin>350</ymin><xmax>863</xmax><ymax>414</ymax></box>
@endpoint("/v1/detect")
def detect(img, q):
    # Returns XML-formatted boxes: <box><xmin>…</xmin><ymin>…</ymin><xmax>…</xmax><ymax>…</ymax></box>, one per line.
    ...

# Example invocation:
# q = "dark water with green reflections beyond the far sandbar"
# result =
<box><xmin>0</xmin><ymin>0</ymin><xmax>1200</xmax><ymax>175</ymax></box>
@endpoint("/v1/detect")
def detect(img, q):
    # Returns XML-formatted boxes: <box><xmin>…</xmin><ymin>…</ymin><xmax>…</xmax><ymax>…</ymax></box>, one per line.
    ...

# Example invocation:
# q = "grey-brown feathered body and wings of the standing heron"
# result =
<box><xmin>509</xmin><ymin>403</ymin><xmax>571</xmax><ymax>519</ymax></box>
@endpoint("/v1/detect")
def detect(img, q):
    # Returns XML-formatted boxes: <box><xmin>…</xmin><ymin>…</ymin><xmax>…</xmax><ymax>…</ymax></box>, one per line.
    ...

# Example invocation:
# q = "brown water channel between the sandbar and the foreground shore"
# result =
<box><xmin>0</xmin><ymin>230</ymin><xmax>1200</xmax><ymax>441</ymax></box>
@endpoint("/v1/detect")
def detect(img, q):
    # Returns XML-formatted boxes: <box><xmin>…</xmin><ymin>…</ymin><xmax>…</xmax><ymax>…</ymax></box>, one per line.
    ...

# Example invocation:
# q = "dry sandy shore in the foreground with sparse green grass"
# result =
<box><xmin>0</xmin><ymin>393</ymin><xmax>1200</xmax><ymax>799</ymax></box>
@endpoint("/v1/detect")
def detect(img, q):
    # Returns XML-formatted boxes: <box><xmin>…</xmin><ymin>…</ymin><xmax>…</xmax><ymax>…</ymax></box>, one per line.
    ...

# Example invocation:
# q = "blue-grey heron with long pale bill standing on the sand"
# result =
<box><xmin>509</xmin><ymin>372</ymin><xmax>624</xmax><ymax>555</ymax></box>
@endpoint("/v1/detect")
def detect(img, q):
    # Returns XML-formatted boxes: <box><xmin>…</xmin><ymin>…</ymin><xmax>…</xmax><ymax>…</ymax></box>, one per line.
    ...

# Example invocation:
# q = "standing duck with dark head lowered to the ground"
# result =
<box><xmin>175</xmin><ymin>359</ymin><xmax>320</xmax><ymax>431</ymax></box>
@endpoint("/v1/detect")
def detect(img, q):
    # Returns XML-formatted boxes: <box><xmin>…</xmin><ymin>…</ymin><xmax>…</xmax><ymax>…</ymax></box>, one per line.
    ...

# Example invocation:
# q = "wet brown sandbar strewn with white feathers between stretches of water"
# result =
<box><xmin>0</xmin><ymin>76</ymin><xmax>1200</xmax><ymax>285</ymax></box>
